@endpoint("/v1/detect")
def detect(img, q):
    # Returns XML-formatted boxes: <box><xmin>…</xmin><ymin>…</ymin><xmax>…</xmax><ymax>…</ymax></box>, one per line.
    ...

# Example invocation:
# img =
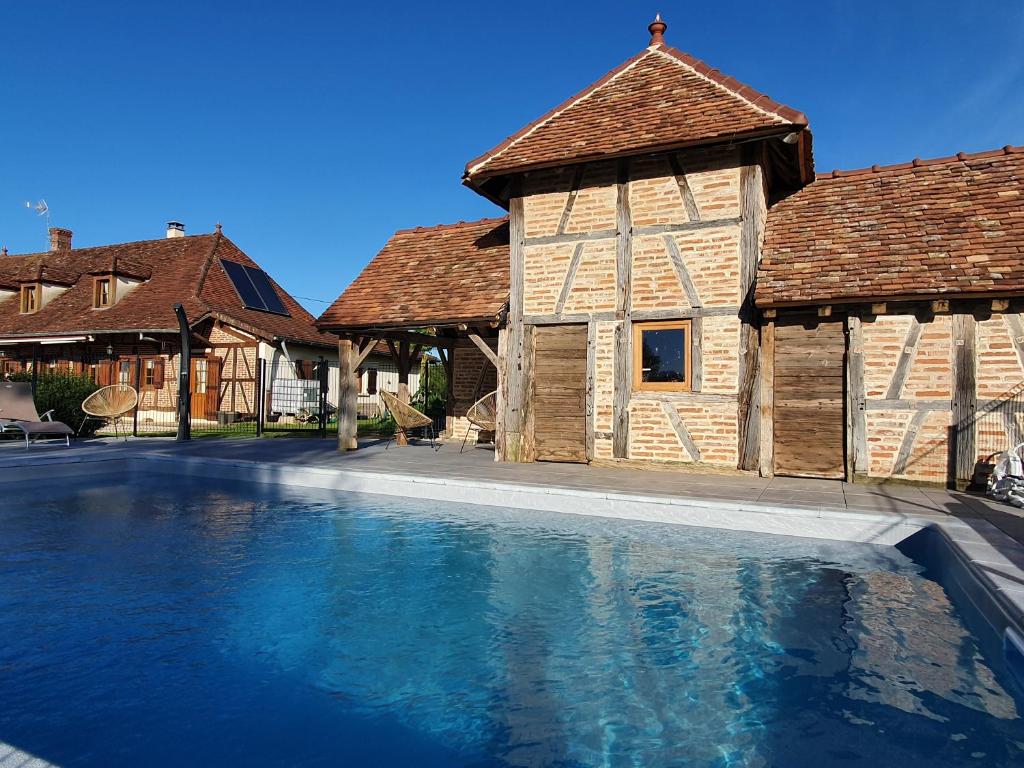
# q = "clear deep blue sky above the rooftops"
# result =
<box><xmin>0</xmin><ymin>0</ymin><xmax>1024</xmax><ymax>314</ymax></box>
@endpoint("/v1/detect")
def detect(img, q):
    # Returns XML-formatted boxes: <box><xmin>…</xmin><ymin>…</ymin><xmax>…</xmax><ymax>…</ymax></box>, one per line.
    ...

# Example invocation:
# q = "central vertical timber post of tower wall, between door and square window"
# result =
<box><xmin>611</xmin><ymin>160</ymin><xmax>633</xmax><ymax>459</ymax></box>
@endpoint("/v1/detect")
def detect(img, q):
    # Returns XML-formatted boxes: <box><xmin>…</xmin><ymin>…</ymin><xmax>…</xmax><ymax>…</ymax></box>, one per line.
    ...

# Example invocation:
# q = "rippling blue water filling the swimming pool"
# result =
<box><xmin>0</xmin><ymin>478</ymin><xmax>1024</xmax><ymax>768</ymax></box>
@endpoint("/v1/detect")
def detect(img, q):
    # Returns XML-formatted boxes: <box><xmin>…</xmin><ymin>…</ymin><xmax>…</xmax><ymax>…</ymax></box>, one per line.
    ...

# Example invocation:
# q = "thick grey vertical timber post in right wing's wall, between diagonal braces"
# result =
<box><xmin>950</xmin><ymin>314</ymin><xmax>978</xmax><ymax>489</ymax></box>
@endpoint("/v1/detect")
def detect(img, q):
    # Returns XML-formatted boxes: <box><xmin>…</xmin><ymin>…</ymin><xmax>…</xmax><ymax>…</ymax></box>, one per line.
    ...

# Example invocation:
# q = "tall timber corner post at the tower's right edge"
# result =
<box><xmin>736</xmin><ymin>153</ymin><xmax>765</xmax><ymax>470</ymax></box>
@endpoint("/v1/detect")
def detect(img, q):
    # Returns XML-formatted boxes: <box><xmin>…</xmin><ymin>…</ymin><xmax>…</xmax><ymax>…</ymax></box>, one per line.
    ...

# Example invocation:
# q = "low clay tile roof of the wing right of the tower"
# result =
<box><xmin>756</xmin><ymin>146</ymin><xmax>1024</xmax><ymax>306</ymax></box>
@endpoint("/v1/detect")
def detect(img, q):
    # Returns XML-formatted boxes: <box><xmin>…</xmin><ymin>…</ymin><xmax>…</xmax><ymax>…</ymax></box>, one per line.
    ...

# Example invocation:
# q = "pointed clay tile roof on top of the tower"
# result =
<box><xmin>465</xmin><ymin>43</ymin><xmax>807</xmax><ymax>182</ymax></box>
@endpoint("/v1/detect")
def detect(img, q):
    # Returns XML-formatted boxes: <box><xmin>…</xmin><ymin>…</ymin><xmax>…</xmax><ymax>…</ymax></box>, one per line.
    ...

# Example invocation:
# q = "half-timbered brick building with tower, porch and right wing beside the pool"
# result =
<box><xmin>318</xmin><ymin>18</ymin><xmax>1024</xmax><ymax>482</ymax></box>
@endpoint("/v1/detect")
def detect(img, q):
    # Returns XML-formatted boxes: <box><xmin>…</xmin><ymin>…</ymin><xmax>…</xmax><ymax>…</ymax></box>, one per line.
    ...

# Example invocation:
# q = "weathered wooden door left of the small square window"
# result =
<box><xmin>534</xmin><ymin>326</ymin><xmax>588</xmax><ymax>462</ymax></box>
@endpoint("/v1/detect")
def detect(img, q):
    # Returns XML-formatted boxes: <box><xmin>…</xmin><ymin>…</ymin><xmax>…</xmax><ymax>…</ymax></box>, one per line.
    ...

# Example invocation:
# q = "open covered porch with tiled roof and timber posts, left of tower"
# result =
<box><xmin>317</xmin><ymin>219</ymin><xmax>509</xmax><ymax>451</ymax></box>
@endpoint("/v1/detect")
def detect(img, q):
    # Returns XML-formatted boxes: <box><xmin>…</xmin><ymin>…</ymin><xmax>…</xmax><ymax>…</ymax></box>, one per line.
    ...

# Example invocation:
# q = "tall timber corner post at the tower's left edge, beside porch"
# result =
<box><xmin>497</xmin><ymin>196</ymin><xmax>525</xmax><ymax>462</ymax></box>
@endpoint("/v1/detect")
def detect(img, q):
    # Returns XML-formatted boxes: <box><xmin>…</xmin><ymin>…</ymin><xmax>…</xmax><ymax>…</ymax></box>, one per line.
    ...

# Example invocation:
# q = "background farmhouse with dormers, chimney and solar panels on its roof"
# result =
<box><xmin>0</xmin><ymin>222</ymin><xmax>393</xmax><ymax>426</ymax></box>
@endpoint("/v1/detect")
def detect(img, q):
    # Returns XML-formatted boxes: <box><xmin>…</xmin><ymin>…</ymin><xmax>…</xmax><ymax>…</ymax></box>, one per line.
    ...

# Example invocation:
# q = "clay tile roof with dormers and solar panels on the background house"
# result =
<box><xmin>0</xmin><ymin>233</ymin><xmax>335</xmax><ymax>345</ymax></box>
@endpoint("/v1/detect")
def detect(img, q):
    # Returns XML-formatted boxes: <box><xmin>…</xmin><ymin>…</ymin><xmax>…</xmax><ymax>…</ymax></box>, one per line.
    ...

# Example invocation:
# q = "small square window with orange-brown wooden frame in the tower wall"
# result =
<box><xmin>633</xmin><ymin>321</ymin><xmax>690</xmax><ymax>392</ymax></box>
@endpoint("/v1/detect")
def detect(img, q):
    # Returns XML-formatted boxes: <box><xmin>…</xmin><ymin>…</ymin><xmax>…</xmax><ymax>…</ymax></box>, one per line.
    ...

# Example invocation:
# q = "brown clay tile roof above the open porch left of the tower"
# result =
<box><xmin>317</xmin><ymin>218</ymin><xmax>509</xmax><ymax>330</ymax></box>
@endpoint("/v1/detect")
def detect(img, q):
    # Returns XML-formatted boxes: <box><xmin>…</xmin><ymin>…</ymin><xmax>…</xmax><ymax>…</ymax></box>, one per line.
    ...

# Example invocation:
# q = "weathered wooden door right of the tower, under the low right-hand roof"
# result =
<box><xmin>774</xmin><ymin>323</ymin><xmax>846</xmax><ymax>478</ymax></box>
